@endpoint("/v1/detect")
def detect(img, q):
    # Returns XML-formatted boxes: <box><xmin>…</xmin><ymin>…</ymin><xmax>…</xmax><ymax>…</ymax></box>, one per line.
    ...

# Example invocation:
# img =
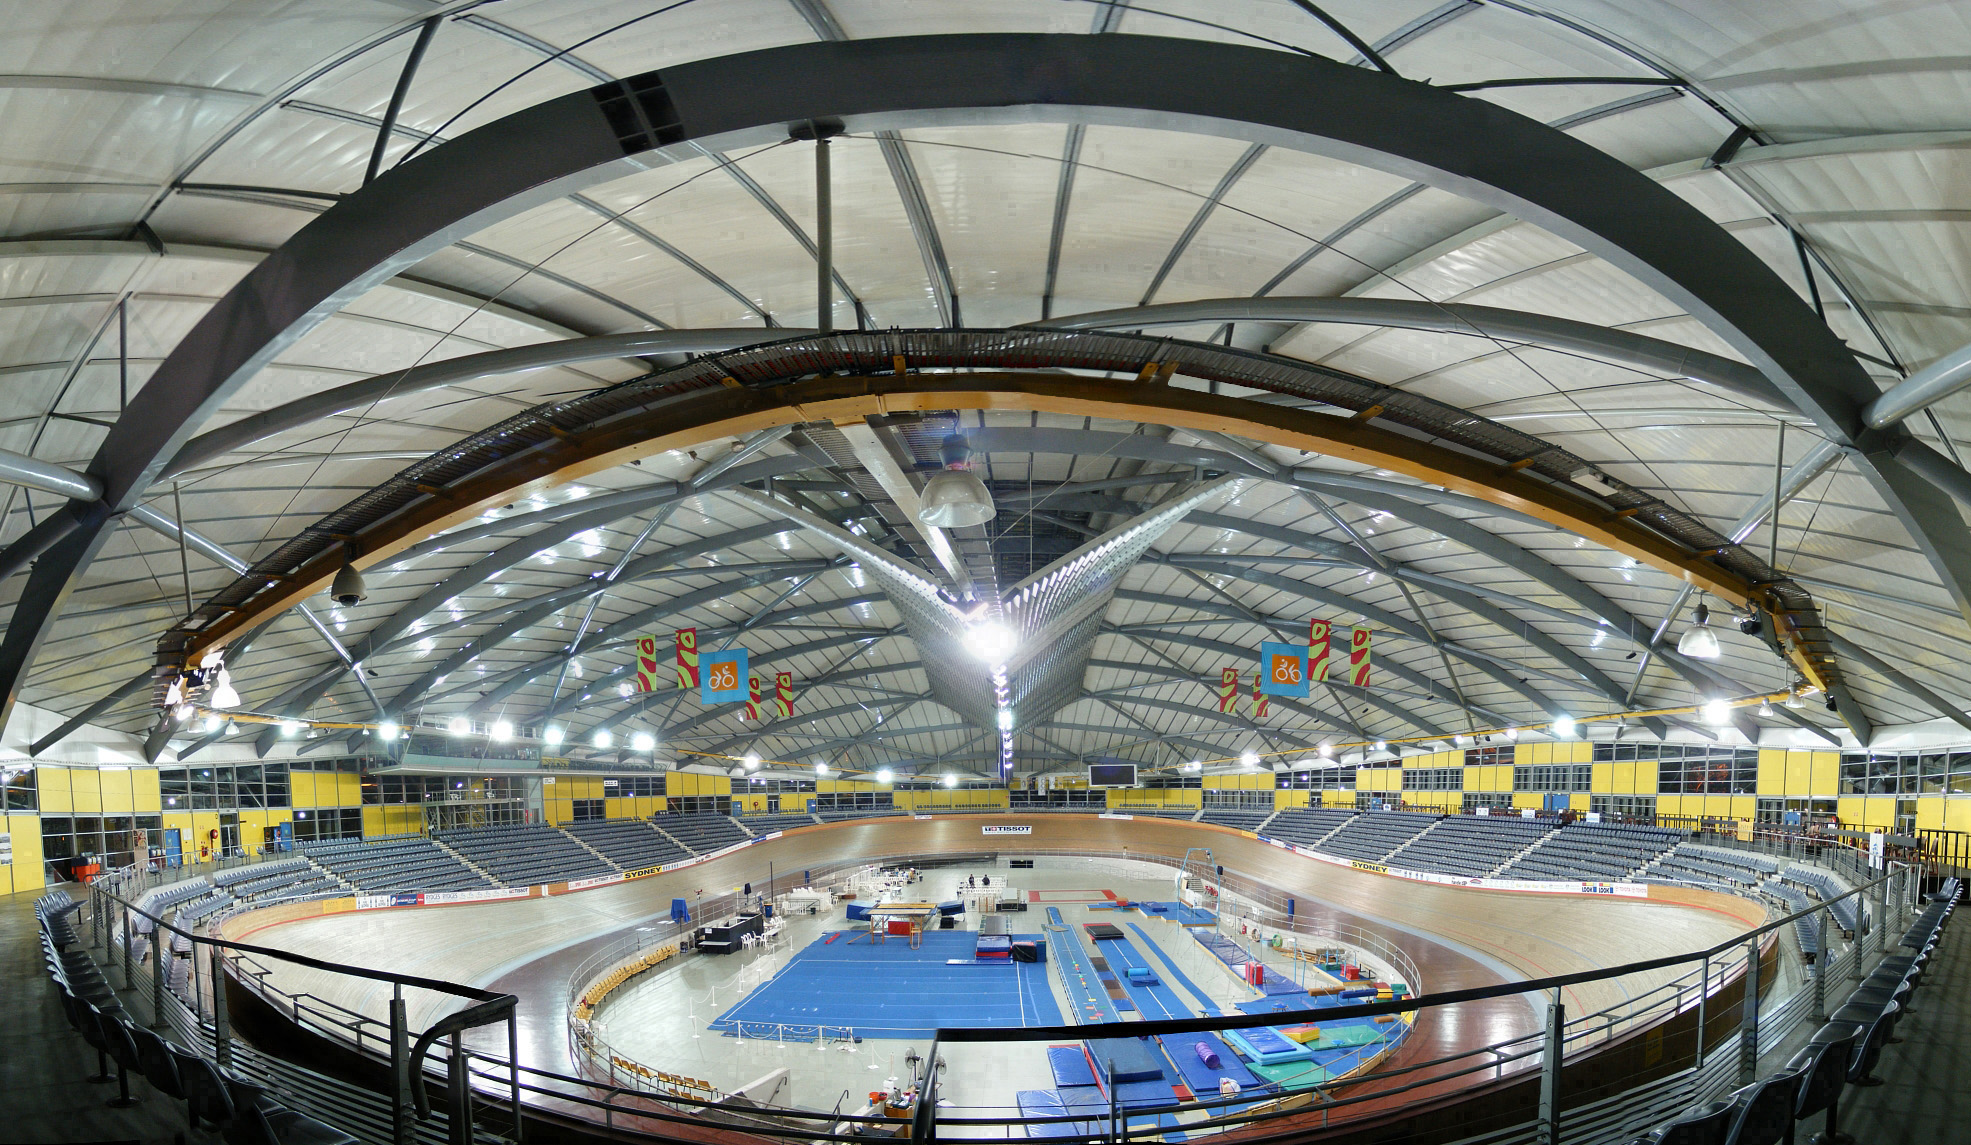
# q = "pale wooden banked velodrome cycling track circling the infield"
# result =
<box><xmin>227</xmin><ymin>814</ymin><xmax>1766</xmax><ymax>1103</ymax></box>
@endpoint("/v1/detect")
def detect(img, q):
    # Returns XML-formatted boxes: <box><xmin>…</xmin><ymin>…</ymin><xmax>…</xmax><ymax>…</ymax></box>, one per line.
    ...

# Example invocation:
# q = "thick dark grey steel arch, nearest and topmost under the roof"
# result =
<box><xmin>11</xmin><ymin>34</ymin><xmax>1907</xmax><ymax>719</ymax></box>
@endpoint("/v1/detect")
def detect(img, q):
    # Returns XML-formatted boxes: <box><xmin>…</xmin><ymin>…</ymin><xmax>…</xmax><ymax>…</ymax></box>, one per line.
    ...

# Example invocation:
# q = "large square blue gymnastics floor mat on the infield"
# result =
<box><xmin>708</xmin><ymin>930</ymin><xmax>1060</xmax><ymax>1041</ymax></box>
